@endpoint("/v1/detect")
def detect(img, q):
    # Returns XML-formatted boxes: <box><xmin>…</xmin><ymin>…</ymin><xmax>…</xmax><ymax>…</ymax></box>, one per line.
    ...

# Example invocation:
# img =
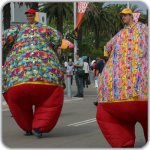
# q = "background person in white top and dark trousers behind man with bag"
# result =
<box><xmin>83</xmin><ymin>59</ymin><xmax>89</xmax><ymax>88</ymax></box>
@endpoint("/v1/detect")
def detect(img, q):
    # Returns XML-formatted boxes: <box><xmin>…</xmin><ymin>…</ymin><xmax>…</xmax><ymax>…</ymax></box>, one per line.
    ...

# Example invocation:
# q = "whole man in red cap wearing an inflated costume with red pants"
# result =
<box><xmin>2</xmin><ymin>9</ymin><xmax>64</xmax><ymax>137</ymax></box>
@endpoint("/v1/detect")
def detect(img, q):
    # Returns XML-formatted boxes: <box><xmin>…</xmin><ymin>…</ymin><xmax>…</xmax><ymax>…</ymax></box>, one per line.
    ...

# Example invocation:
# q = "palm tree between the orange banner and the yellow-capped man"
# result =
<box><xmin>83</xmin><ymin>2</ymin><xmax>113</xmax><ymax>49</ymax></box>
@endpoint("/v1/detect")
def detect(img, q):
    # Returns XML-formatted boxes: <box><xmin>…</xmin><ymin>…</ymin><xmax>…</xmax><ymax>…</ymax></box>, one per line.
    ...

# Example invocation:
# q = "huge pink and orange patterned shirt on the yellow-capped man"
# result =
<box><xmin>98</xmin><ymin>23</ymin><xmax>148</xmax><ymax>103</ymax></box>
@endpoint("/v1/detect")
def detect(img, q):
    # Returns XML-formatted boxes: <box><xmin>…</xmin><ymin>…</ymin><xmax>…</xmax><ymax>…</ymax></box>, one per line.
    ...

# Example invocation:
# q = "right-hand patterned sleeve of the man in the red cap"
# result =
<box><xmin>49</xmin><ymin>27</ymin><xmax>62</xmax><ymax>51</ymax></box>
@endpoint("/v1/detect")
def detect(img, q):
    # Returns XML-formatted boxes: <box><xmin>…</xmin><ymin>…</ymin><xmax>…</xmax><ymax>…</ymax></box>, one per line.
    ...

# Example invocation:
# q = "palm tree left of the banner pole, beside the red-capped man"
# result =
<box><xmin>40</xmin><ymin>2</ymin><xmax>73</xmax><ymax>34</ymax></box>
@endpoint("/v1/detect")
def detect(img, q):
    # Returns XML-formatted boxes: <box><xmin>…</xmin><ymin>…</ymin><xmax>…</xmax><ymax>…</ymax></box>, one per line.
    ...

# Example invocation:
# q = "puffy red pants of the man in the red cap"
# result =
<box><xmin>3</xmin><ymin>84</ymin><xmax>64</xmax><ymax>132</ymax></box>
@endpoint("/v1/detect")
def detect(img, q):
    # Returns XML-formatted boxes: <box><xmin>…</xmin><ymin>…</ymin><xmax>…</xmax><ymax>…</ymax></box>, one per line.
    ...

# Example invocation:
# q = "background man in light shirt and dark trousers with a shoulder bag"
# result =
<box><xmin>73</xmin><ymin>53</ymin><xmax>84</xmax><ymax>97</ymax></box>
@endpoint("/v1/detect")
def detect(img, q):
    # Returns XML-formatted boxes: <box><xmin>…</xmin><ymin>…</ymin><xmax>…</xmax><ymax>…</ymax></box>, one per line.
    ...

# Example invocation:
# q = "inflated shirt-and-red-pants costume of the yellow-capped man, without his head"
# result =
<box><xmin>96</xmin><ymin>23</ymin><xmax>148</xmax><ymax>148</ymax></box>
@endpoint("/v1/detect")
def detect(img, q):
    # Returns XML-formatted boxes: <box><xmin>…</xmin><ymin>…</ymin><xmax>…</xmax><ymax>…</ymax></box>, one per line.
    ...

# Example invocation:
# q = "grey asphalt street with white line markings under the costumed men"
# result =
<box><xmin>2</xmin><ymin>77</ymin><xmax>146</xmax><ymax>148</ymax></box>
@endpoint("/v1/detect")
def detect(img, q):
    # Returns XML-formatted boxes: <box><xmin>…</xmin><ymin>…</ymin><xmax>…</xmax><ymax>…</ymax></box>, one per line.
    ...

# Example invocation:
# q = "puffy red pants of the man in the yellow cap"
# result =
<box><xmin>96</xmin><ymin>101</ymin><xmax>148</xmax><ymax>148</ymax></box>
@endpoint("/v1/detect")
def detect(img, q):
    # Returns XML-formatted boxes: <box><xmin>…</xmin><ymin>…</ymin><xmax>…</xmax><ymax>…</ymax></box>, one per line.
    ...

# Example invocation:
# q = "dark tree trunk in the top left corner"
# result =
<box><xmin>3</xmin><ymin>3</ymin><xmax>11</xmax><ymax>30</ymax></box>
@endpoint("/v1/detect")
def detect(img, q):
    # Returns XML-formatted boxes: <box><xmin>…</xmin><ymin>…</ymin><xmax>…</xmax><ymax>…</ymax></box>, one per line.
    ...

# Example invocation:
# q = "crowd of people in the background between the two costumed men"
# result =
<box><xmin>60</xmin><ymin>53</ymin><xmax>108</xmax><ymax>98</ymax></box>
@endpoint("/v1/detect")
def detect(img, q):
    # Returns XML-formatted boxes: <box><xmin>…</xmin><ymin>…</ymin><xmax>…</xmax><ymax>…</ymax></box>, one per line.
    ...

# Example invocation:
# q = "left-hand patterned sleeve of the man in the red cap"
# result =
<box><xmin>2</xmin><ymin>25</ymin><xmax>19</xmax><ymax>45</ymax></box>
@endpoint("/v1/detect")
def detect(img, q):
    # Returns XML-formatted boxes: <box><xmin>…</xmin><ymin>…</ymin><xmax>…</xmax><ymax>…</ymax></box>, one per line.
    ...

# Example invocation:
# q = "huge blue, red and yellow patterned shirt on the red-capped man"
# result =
<box><xmin>2</xmin><ymin>22</ymin><xmax>64</xmax><ymax>93</ymax></box>
